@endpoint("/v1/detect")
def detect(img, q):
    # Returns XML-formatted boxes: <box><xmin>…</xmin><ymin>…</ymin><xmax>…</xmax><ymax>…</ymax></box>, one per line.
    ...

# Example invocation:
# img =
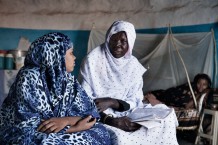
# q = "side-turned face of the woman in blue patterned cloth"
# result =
<box><xmin>65</xmin><ymin>48</ymin><xmax>76</xmax><ymax>73</ymax></box>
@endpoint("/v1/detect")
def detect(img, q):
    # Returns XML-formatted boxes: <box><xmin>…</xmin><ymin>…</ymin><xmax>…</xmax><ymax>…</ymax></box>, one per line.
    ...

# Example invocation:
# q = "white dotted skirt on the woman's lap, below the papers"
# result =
<box><xmin>105</xmin><ymin>104</ymin><xmax>178</xmax><ymax>145</ymax></box>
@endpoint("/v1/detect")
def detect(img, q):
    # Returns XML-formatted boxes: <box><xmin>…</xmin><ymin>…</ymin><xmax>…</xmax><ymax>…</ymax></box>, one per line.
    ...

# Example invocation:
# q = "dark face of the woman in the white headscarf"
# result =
<box><xmin>109</xmin><ymin>31</ymin><xmax>129</xmax><ymax>58</ymax></box>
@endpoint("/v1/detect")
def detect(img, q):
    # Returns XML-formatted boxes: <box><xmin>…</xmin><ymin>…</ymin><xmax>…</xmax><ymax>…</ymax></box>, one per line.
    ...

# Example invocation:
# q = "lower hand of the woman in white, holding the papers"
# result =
<box><xmin>108</xmin><ymin>116</ymin><xmax>141</xmax><ymax>132</ymax></box>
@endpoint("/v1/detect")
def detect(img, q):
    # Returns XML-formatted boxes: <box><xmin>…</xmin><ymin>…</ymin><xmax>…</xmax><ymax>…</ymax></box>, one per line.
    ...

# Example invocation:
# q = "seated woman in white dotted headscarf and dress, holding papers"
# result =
<box><xmin>80</xmin><ymin>21</ymin><xmax>178</xmax><ymax>145</ymax></box>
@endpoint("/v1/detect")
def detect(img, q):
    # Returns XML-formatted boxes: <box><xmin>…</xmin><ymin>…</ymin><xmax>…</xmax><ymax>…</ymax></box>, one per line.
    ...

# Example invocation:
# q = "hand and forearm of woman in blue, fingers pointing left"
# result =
<box><xmin>37</xmin><ymin>116</ymin><xmax>81</xmax><ymax>133</ymax></box>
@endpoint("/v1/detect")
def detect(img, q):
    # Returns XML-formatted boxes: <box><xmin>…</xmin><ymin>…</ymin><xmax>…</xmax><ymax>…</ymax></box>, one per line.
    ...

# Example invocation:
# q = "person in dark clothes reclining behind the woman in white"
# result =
<box><xmin>144</xmin><ymin>74</ymin><xmax>213</xmax><ymax>110</ymax></box>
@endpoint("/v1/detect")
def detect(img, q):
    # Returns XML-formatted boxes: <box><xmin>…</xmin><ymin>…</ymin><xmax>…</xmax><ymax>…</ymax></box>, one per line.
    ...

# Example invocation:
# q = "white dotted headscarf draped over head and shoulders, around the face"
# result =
<box><xmin>80</xmin><ymin>21</ymin><xmax>146</xmax><ymax>115</ymax></box>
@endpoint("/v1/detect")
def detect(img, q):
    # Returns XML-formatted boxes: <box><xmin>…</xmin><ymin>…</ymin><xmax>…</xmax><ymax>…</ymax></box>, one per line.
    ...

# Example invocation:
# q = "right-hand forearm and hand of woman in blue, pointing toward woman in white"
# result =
<box><xmin>66</xmin><ymin>115</ymin><xmax>96</xmax><ymax>133</ymax></box>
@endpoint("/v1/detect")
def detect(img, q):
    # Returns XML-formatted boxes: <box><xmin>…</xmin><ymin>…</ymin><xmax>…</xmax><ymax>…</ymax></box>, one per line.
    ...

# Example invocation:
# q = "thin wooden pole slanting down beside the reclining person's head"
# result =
<box><xmin>169</xmin><ymin>26</ymin><xmax>197</xmax><ymax>108</ymax></box>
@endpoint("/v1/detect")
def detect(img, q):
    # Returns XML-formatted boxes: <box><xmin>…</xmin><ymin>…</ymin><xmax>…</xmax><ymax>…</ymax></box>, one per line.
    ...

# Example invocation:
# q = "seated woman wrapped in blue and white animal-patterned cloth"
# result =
<box><xmin>0</xmin><ymin>33</ymin><xmax>110</xmax><ymax>145</ymax></box>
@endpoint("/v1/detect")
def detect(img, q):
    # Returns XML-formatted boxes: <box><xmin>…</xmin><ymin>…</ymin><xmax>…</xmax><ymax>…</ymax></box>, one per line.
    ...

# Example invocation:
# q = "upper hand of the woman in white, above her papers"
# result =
<box><xmin>94</xmin><ymin>98</ymin><xmax>119</xmax><ymax>112</ymax></box>
